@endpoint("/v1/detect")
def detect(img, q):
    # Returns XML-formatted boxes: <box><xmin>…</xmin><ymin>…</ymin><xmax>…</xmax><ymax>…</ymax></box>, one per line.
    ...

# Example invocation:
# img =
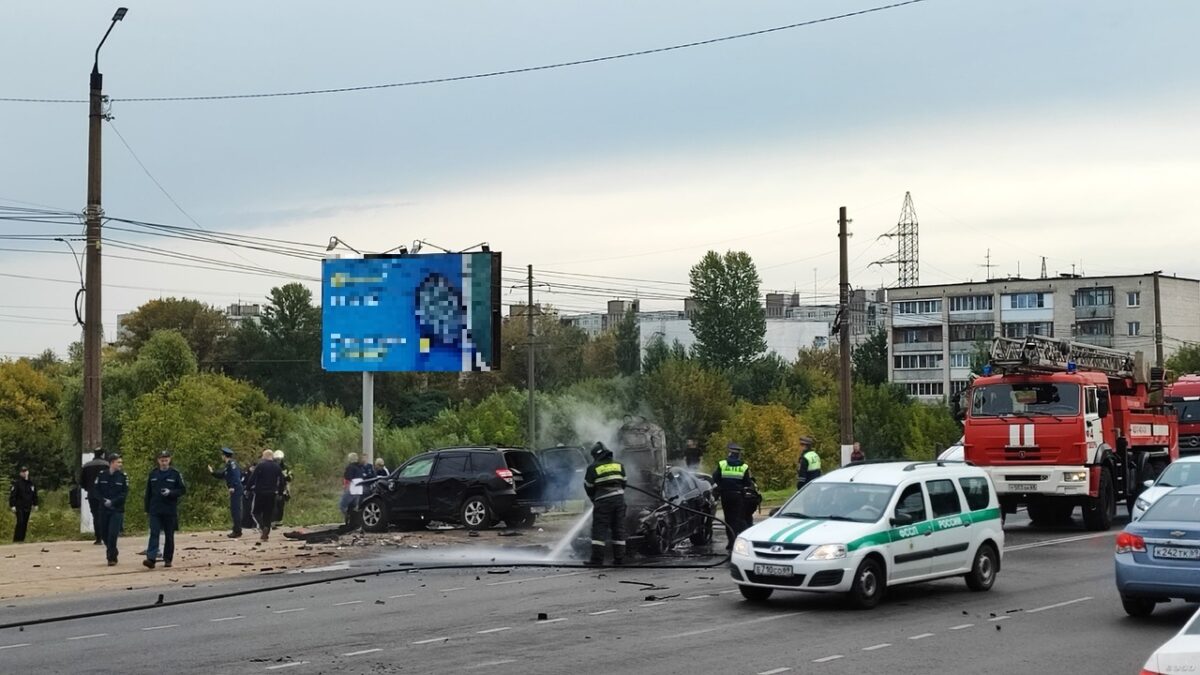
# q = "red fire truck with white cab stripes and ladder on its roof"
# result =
<box><xmin>960</xmin><ymin>335</ymin><xmax>1180</xmax><ymax>531</ymax></box>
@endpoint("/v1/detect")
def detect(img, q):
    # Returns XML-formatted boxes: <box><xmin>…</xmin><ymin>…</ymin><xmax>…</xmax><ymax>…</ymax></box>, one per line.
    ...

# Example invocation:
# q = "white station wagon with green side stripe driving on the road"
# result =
<box><xmin>730</xmin><ymin>461</ymin><xmax>1004</xmax><ymax>609</ymax></box>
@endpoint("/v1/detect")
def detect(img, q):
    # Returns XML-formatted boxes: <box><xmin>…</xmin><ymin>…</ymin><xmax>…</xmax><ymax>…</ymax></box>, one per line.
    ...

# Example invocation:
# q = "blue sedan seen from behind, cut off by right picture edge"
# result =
<box><xmin>1116</xmin><ymin>485</ymin><xmax>1200</xmax><ymax>616</ymax></box>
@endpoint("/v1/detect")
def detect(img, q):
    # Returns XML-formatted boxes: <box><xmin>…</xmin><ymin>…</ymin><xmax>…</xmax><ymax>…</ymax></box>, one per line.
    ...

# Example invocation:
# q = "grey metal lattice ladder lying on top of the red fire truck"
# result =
<box><xmin>991</xmin><ymin>335</ymin><xmax>1135</xmax><ymax>377</ymax></box>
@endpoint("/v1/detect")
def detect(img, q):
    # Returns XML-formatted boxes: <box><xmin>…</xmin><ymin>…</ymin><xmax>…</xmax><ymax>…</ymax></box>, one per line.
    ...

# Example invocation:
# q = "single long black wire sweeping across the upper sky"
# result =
<box><xmin>0</xmin><ymin>0</ymin><xmax>925</xmax><ymax>103</ymax></box>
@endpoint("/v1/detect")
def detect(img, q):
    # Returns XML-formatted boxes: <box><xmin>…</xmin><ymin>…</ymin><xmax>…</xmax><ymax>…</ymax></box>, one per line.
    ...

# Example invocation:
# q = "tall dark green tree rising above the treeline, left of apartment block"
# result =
<box><xmin>690</xmin><ymin>251</ymin><xmax>767</xmax><ymax>370</ymax></box>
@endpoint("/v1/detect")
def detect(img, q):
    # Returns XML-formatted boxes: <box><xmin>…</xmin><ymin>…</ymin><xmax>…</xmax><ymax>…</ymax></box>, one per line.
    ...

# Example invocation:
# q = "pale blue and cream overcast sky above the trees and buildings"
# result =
<box><xmin>0</xmin><ymin>0</ymin><xmax>1200</xmax><ymax>356</ymax></box>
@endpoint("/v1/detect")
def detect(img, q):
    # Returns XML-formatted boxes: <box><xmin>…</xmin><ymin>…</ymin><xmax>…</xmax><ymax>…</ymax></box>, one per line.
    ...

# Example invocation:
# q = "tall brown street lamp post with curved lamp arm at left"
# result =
<box><xmin>83</xmin><ymin>7</ymin><xmax>128</xmax><ymax>459</ymax></box>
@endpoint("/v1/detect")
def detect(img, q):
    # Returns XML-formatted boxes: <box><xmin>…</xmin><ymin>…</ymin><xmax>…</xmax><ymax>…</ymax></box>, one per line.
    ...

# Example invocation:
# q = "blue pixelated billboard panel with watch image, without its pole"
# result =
<box><xmin>320</xmin><ymin>252</ymin><xmax>500</xmax><ymax>372</ymax></box>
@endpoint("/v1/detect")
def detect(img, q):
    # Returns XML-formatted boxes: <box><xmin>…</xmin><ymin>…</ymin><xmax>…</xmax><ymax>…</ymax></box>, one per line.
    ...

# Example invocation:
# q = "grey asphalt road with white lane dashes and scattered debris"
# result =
<box><xmin>0</xmin><ymin>511</ymin><xmax>1195</xmax><ymax>675</ymax></box>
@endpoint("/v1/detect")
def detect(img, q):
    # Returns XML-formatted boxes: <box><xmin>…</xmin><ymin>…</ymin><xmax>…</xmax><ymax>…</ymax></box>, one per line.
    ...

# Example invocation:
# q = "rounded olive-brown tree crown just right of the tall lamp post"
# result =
<box><xmin>118</xmin><ymin>298</ymin><xmax>229</xmax><ymax>363</ymax></box>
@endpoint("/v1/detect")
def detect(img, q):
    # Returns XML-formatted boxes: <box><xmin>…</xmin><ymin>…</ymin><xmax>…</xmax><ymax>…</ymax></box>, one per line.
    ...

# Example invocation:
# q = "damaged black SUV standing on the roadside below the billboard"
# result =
<box><xmin>359</xmin><ymin>448</ymin><xmax>547</xmax><ymax>532</ymax></box>
